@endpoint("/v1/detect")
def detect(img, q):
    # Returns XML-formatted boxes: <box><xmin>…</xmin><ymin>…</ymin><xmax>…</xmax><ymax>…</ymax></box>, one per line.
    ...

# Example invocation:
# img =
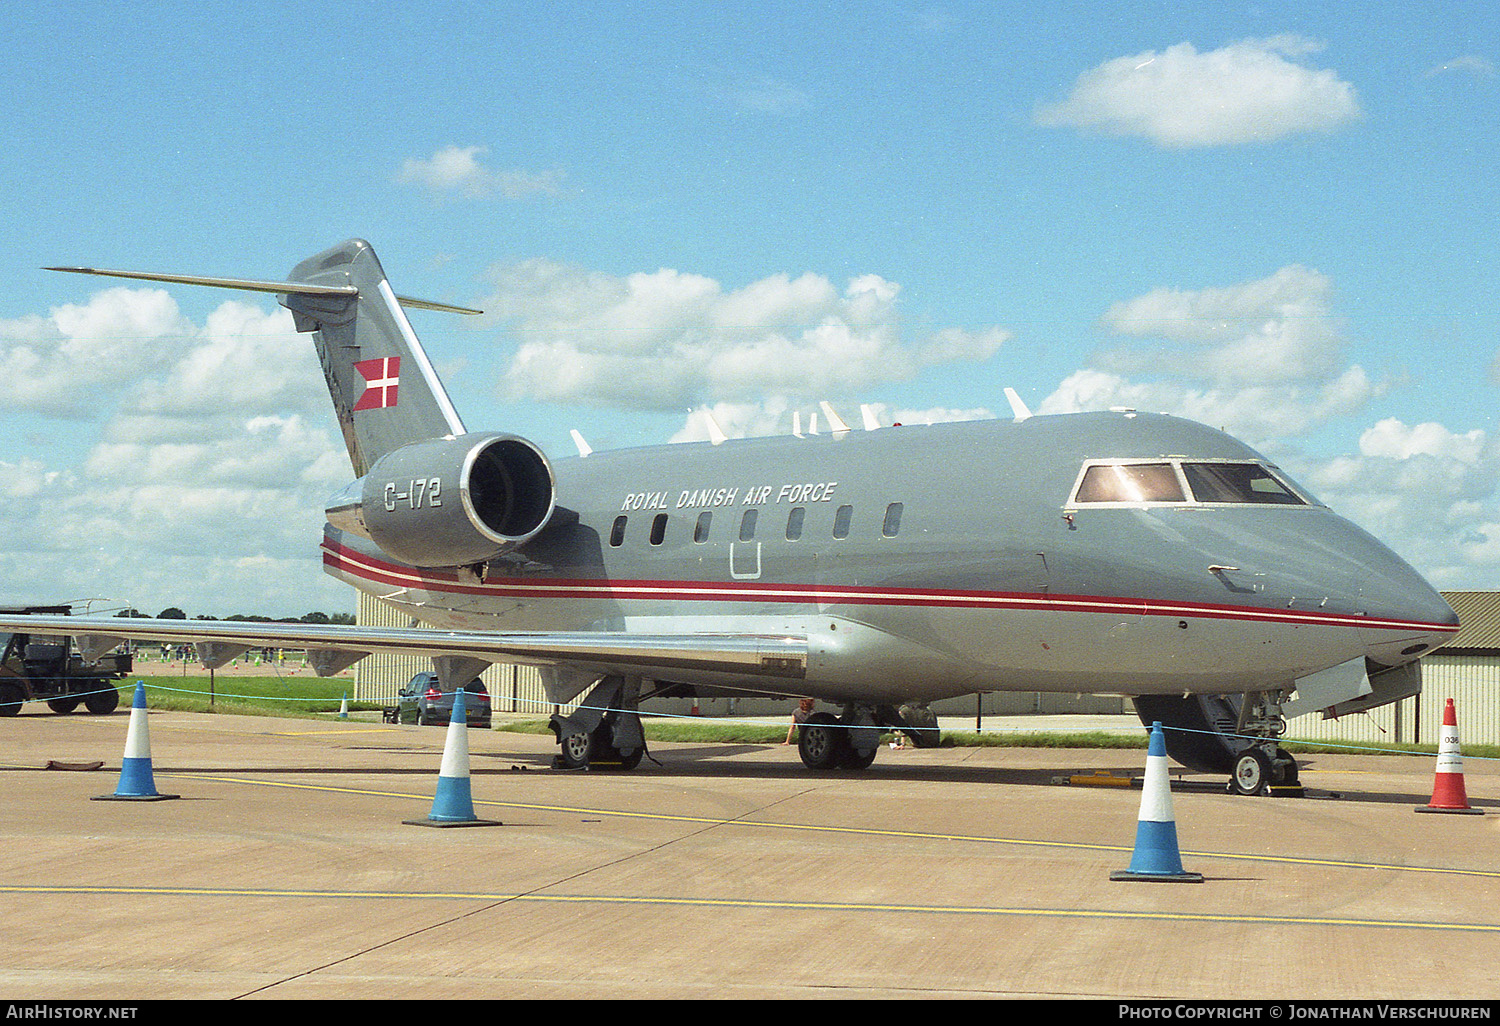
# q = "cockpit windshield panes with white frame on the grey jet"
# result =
<box><xmin>1071</xmin><ymin>459</ymin><xmax>1308</xmax><ymax>506</ymax></box>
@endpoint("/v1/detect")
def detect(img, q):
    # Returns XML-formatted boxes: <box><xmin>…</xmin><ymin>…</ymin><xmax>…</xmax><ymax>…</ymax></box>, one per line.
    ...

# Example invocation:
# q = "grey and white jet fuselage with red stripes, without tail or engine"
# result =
<box><xmin>324</xmin><ymin>413</ymin><xmax>1457</xmax><ymax>702</ymax></box>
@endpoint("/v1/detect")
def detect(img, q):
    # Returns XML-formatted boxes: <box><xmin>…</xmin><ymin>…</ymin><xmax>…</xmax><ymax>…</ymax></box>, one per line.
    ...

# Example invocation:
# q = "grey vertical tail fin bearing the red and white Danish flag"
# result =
<box><xmin>281</xmin><ymin>239</ymin><xmax>465</xmax><ymax>477</ymax></box>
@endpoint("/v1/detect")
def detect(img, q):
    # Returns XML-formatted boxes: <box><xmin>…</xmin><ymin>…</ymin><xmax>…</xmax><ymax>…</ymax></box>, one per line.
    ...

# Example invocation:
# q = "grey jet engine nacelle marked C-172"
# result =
<box><xmin>326</xmin><ymin>434</ymin><xmax>557</xmax><ymax>567</ymax></box>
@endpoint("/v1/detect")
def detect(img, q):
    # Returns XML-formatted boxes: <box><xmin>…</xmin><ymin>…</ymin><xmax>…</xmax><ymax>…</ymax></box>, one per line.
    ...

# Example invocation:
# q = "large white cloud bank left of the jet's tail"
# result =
<box><xmin>0</xmin><ymin>288</ymin><xmax>351</xmax><ymax>615</ymax></box>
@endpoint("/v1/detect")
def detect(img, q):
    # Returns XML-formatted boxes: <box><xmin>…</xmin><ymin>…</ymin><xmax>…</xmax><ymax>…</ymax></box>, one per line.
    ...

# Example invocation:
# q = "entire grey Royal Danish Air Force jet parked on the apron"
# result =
<box><xmin>0</xmin><ymin>240</ymin><xmax>1458</xmax><ymax>794</ymax></box>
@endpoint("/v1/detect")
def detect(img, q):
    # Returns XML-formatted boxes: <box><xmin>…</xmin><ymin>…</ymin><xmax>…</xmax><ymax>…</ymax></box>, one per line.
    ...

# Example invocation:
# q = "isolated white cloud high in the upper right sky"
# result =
<box><xmin>1035</xmin><ymin>35</ymin><xmax>1361</xmax><ymax>147</ymax></box>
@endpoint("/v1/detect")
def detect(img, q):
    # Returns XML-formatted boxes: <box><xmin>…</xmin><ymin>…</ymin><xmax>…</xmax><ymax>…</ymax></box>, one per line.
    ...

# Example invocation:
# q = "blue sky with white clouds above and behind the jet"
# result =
<box><xmin>0</xmin><ymin>0</ymin><xmax>1500</xmax><ymax>617</ymax></box>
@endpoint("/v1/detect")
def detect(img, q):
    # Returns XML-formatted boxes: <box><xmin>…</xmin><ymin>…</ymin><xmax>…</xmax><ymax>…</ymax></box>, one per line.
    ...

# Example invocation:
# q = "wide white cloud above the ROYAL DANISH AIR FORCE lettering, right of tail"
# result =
<box><xmin>485</xmin><ymin>260</ymin><xmax>1008</xmax><ymax>410</ymax></box>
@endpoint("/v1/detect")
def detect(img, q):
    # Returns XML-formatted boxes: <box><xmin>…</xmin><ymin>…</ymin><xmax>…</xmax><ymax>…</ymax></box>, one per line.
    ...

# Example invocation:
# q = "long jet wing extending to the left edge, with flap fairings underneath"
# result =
<box><xmin>0</xmin><ymin>614</ymin><xmax>807</xmax><ymax>692</ymax></box>
